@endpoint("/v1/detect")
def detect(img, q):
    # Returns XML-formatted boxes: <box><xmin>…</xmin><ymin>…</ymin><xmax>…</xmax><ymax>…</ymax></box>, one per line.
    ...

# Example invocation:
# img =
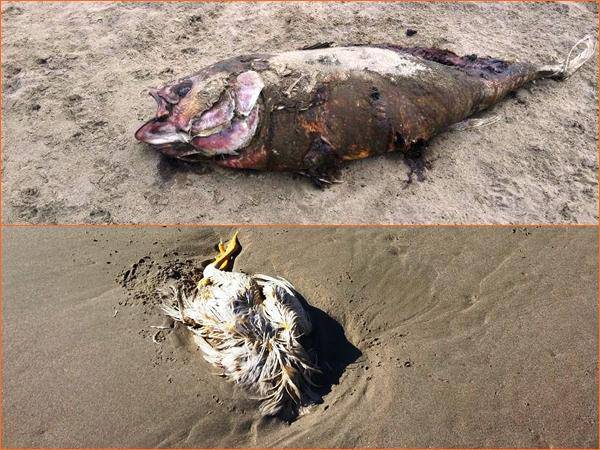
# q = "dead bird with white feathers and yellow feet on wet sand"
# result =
<box><xmin>162</xmin><ymin>233</ymin><xmax>320</xmax><ymax>419</ymax></box>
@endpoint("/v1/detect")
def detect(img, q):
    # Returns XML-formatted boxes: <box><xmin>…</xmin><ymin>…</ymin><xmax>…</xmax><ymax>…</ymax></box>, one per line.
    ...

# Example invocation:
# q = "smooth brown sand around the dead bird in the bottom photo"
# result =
<box><xmin>3</xmin><ymin>228</ymin><xmax>598</xmax><ymax>448</ymax></box>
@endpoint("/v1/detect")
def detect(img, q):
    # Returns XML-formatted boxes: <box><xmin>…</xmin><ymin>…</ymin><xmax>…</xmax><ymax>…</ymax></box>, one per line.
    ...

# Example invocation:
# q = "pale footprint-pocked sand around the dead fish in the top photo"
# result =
<box><xmin>2</xmin><ymin>2</ymin><xmax>598</xmax><ymax>223</ymax></box>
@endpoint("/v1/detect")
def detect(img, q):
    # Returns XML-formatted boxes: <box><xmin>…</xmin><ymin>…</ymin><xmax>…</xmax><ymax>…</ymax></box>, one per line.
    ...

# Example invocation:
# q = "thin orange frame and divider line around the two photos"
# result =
<box><xmin>0</xmin><ymin>0</ymin><xmax>600</xmax><ymax>450</ymax></box>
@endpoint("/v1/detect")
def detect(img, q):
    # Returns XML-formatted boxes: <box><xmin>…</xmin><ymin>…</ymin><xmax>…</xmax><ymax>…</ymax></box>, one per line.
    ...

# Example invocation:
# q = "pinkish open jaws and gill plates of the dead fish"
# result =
<box><xmin>135</xmin><ymin>71</ymin><xmax>264</xmax><ymax>161</ymax></box>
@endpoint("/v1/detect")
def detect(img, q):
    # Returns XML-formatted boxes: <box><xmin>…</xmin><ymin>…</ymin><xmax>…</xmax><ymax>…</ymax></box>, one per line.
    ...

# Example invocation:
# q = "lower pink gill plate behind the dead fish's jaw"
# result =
<box><xmin>191</xmin><ymin>105</ymin><xmax>258</xmax><ymax>156</ymax></box>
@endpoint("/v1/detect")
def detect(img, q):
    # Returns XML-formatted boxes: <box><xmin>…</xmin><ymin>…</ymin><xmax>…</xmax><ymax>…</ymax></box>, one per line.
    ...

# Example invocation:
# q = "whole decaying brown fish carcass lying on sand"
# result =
<box><xmin>135</xmin><ymin>36</ymin><xmax>595</xmax><ymax>184</ymax></box>
